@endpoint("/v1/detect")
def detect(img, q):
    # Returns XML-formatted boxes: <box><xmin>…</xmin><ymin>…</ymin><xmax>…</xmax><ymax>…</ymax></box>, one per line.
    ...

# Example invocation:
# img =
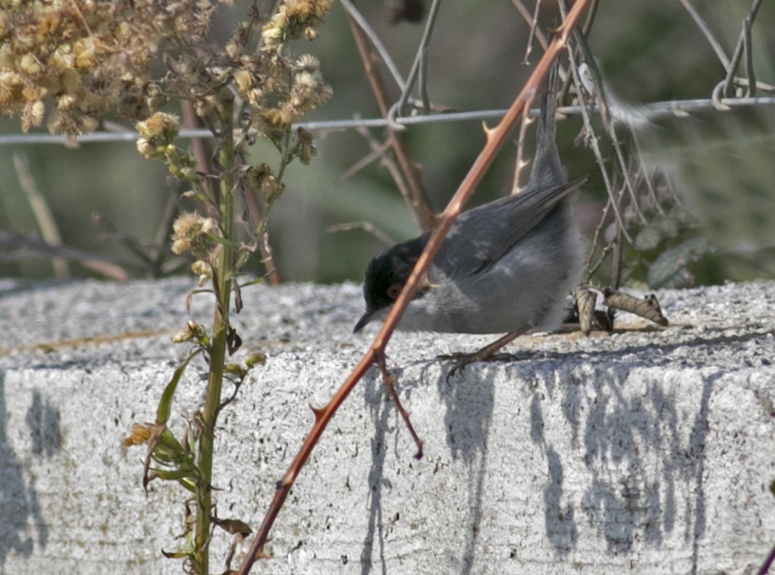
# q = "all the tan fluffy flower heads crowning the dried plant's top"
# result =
<box><xmin>0</xmin><ymin>0</ymin><xmax>332</xmax><ymax>169</ymax></box>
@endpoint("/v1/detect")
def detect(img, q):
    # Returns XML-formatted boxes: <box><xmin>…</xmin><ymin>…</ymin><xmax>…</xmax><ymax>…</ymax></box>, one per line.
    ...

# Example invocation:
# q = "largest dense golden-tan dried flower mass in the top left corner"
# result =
<box><xmin>0</xmin><ymin>0</ymin><xmax>213</xmax><ymax>134</ymax></box>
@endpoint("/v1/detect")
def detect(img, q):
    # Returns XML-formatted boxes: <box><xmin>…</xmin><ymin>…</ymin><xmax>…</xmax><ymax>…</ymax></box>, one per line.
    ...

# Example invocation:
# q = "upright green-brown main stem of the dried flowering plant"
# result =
<box><xmin>194</xmin><ymin>91</ymin><xmax>234</xmax><ymax>575</ymax></box>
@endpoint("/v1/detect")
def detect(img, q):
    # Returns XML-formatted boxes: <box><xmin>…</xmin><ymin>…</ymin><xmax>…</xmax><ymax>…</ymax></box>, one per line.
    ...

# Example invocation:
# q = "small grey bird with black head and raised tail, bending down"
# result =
<box><xmin>354</xmin><ymin>64</ymin><xmax>585</xmax><ymax>367</ymax></box>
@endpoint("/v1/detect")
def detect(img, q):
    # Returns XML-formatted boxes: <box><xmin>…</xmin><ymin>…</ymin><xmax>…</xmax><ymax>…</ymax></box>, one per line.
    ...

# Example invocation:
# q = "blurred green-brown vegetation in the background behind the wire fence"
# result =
<box><xmin>0</xmin><ymin>0</ymin><xmax>775</xmax><ymax>287</ymax></box>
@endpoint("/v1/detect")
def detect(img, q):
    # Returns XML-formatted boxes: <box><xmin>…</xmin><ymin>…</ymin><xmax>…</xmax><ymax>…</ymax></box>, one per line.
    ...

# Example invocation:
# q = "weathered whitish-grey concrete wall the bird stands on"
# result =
<box><xmin>0</xmin><ymin>280</ymin><xmax>775</xmax><ymax>575</ymax></box>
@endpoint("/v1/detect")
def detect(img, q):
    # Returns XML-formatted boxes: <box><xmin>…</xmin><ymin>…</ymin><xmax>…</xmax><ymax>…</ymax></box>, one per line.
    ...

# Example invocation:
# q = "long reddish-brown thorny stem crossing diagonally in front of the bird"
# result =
<box><xmin>233</xmin><ymin>0</ymin><xmax>590</xmax><ymax>575</ymax></box>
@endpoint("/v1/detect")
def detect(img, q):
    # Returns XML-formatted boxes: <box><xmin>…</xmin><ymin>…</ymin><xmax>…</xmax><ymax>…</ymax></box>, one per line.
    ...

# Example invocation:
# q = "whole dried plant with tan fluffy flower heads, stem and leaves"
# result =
<box><xmin>0</xmin><ymin>0</ymin><xmax>332</xmax><ymax>574</ymax></box>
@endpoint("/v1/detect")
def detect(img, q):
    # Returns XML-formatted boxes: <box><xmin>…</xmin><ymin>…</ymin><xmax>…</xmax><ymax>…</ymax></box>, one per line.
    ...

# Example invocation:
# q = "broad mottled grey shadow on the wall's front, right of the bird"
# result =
<box><xmin>514</xmin><ymin>362</ymin><xmax>721</xmax><ymax>573</ymax></box>
